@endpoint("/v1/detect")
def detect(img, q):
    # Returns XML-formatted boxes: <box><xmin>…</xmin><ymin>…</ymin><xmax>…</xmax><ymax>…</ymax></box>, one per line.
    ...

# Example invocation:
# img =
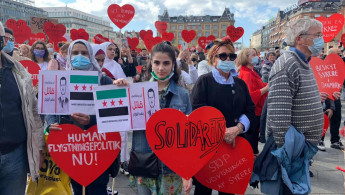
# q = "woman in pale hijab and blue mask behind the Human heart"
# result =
<box><xmin>47</xmin><ymin>39</ymin><xmax>128</xmax><ymax>195</ymax></box>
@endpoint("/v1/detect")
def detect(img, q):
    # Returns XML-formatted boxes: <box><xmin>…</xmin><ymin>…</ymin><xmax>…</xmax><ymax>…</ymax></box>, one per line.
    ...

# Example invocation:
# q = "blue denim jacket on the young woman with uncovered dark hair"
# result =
<box><xmin>132</xmin><ymin>80</ymin><xmax>192</xmax><ymax>174</ymax></box>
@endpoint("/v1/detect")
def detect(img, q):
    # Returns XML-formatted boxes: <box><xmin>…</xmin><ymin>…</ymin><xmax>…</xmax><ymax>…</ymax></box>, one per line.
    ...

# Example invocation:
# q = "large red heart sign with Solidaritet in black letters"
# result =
<box><xmin>146</xmin><ymin>107</ymin><xmax>226</xmax><ymax>179</ymax></box>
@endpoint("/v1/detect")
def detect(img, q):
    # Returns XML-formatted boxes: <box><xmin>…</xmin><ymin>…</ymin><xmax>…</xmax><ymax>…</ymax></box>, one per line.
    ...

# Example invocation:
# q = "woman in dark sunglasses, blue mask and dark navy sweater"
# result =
<box><xmin>191</xmin><ymin>37</ymin><xmax>255</xmax><ymax>195</ymax></box>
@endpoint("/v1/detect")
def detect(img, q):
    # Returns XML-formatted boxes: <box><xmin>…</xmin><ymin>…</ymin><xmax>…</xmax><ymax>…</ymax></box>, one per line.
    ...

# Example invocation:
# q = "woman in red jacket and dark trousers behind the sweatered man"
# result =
<box><xmin>237</xmin><ymin>48</ymin><xmax>268</xmax><ymax>157</ymax></box>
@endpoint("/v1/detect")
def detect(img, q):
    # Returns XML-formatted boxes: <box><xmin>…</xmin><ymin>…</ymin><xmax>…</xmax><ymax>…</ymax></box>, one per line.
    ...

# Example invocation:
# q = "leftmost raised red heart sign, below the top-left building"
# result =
<box><xmin>6</xmin><ymin>19</ymin><xmax>31</xmax><ymax>44</ymax></box>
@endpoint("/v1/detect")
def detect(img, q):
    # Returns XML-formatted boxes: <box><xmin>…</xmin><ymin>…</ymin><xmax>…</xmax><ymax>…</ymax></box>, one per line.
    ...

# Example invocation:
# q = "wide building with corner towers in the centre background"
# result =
<box><xmin>158</xmin><ymin>8</ymin><xmax>235</xmax><ymax>46</ymax></box>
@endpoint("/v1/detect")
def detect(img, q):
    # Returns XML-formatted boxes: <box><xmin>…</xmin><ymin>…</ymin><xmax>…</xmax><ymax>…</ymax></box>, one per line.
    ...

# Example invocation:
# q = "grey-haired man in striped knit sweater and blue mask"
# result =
<box><xmin>267</xmin><ymin>18</ymin><xmax>327</xmax><ymax>194</ymax></box>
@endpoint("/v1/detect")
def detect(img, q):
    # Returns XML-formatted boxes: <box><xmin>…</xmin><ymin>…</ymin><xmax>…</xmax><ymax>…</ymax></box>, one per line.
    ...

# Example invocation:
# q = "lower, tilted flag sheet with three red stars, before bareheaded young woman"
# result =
<box><xmin>94</xmin><ymin>86</ymin><xmax>131</xmax><ymax>133</ymax></box>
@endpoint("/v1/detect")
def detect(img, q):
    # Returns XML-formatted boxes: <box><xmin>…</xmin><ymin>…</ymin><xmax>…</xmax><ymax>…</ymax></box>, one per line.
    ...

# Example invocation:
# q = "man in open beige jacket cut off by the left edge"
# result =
<box><xmin>0</xmin><ymin>22</ymin><xmax>44</xmax><ymax>195</ymax></box>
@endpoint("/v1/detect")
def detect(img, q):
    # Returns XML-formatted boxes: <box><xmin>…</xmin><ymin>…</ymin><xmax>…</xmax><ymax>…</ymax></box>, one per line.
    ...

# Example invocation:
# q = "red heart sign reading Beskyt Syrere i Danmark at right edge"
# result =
<box><xmin>309</xmin><ymin>53</ymin><xmax>345</xmax><ymax>100</ymax></box>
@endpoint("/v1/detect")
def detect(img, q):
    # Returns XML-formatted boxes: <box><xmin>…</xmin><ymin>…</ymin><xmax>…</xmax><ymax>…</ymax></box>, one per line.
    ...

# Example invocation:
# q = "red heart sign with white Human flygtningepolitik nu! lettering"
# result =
<box><xmin>47</xmin><ymin>124</ymin><xmax>121</xmax><ymax>186</ymax></box>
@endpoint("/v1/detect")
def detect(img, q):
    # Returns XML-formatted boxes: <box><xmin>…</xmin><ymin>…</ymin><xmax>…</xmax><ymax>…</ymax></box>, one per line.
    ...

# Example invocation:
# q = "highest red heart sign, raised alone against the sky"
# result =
<box><xmin>108</xmin><ymin>4</ymin><xmax>135</xmax><ymax>29</ymax></box>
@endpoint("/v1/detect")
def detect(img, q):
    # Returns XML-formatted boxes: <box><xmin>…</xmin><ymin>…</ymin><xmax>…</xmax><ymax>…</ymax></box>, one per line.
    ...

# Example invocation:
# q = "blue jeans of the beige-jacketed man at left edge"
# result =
<box><xmin>0</xmin><ymin>142</ymin><xmax>29</xmax><ymax>195</ymax></box>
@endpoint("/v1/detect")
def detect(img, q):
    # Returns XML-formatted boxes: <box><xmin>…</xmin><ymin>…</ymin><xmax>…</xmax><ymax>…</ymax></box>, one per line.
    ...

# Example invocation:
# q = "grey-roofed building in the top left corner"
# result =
<box><xmin>0</xmin><ymin>0</ymin><xmax>47</xmax><ymax>26</ymax></box>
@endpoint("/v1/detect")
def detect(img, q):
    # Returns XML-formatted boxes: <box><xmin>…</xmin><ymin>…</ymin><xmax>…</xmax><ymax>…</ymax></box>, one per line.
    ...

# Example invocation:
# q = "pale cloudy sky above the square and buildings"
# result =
<box><xmin>35</xmin><ymin>0</ymin><xmax>298</xmax><ymax>46</ymax></box>
